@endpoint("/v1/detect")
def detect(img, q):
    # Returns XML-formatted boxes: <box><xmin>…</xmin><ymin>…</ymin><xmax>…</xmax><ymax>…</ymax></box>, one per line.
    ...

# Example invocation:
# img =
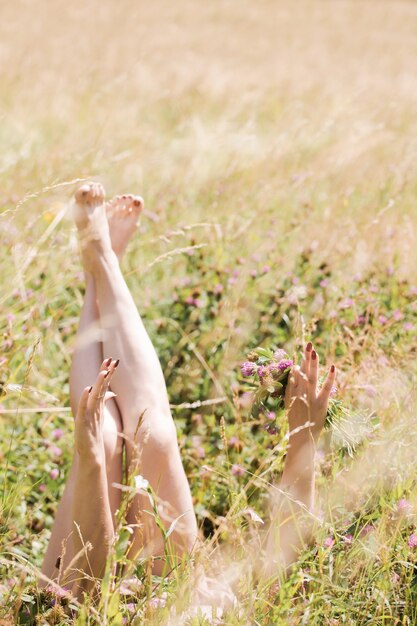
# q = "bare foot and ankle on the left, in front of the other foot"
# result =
<box><xmin>75</xmin><ymin>183</ymin><xmax>111</xmax><ymax>271</ymax></box>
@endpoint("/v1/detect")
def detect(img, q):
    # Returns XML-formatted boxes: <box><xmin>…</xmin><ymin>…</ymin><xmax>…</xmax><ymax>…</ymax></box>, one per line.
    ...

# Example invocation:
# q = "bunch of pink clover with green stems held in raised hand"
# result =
<box><xmin>241</xmin><ymin>348</ymin><xmax>356</xmax><ymax>453</ymax></box>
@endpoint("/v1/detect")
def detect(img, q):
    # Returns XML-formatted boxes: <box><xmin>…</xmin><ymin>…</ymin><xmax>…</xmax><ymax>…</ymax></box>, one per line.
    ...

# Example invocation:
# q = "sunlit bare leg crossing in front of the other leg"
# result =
<box><xmin>76</xmin><ymin>179</ymin><xmax>197</xmax><ymax>573</ymax></box>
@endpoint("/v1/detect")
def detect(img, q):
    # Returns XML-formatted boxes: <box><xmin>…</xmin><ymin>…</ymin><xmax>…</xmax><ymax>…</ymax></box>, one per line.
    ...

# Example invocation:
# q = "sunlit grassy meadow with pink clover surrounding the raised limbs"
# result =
<box><xmin>0</xmin><ymin>0</ymin><xmax>417</xmax><ymax>626</ymax></box>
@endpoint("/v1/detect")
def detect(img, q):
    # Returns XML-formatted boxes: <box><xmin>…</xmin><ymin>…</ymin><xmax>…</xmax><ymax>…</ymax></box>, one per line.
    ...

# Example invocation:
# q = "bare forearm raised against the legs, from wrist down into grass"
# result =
<box><xmin>72</xmin><ymin>456</ymin><xmax>114</xmax><ymax>599</ymax></box>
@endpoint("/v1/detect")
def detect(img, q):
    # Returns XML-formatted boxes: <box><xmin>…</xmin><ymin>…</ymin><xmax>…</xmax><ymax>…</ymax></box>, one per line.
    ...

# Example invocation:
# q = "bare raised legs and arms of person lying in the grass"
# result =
<box><xmin>42</xmin><ymin>183</ymin><xmax>335</xmax><ymax>598</ymax></box>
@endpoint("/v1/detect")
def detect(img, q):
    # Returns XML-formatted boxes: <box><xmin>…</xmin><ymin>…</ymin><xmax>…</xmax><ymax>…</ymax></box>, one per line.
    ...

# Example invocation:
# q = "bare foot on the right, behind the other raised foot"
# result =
<box><xmin>106</xmin><ymin>194</ymin><xmax>143</xmax><ymax>259</ymax></box>
